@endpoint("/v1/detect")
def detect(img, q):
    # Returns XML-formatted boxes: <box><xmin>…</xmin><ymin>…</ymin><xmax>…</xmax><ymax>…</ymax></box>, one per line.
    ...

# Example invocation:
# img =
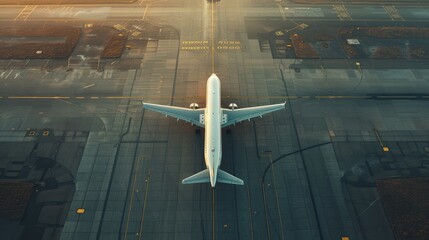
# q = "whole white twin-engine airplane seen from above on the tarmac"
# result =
<box><xmin>142</xmin><ymin>73</ymin><xmax>286</xmax><ymax>188</ymax></box>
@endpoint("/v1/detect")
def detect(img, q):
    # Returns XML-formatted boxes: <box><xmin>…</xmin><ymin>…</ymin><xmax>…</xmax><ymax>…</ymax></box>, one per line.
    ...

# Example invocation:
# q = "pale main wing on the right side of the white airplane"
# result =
<box><xmin>222</xmin><ymin>102</ymin><xmax>286</xmax><ymax>127</ymax></box>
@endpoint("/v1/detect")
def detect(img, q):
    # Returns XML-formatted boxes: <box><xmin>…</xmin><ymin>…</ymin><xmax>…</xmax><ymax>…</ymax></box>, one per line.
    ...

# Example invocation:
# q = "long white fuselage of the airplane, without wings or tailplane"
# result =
<box><xmin>204</xmin><ymin>74</ymin><xmax>222</xmax><ymax>187</ymax></box>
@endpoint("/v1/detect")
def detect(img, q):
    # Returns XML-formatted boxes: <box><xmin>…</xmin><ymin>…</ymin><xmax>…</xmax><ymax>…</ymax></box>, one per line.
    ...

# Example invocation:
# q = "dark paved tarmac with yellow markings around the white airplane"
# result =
<box><xmin>0</xmin><ymin>0</ymin><xmax>429</xmax><ymax>240</ymax></box>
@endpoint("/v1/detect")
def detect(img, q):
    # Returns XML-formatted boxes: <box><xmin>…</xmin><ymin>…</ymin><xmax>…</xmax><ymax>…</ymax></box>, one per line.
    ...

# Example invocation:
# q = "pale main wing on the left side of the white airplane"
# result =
<box><xmin>142</xmin><ymin>102</ymin><xmax>204</xmax><ymax>127</ymax></box>
